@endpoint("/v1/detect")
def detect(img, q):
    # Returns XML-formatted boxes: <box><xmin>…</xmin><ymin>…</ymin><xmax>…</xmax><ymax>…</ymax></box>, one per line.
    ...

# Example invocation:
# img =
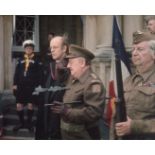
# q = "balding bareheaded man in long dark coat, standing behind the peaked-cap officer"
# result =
<box><xmin>35</xmin><ymin>36</ymin><xmax>70</xmax><ymax>140</ymax></box>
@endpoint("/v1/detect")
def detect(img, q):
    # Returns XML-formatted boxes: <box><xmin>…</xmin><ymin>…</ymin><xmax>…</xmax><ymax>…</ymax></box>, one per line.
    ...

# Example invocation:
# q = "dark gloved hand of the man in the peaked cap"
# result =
<box><xmin>51</xmin><ymin>101</ymin><xmax>67</xmax><ymax>114</ymax></box>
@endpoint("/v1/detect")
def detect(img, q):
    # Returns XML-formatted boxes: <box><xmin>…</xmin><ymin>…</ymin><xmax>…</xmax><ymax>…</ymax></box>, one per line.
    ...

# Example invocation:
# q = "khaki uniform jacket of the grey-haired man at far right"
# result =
<box><xmin>124</xmin><ymin>65</ymin><xmax>155</xmax><ymax>139</ymax></box>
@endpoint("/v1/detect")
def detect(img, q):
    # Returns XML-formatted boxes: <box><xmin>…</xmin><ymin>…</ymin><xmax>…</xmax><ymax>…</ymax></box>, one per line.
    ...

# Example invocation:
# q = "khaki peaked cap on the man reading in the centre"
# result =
<box><xmin>66</xmin><ymin>44</ymin><xmax>95</xmax><ymax>60</ymax></box>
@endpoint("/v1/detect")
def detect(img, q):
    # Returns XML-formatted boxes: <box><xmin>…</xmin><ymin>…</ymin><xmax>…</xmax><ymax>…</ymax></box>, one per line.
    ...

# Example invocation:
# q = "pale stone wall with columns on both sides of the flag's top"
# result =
<box><xmin>83</xmin><ymin>15</ymin><xmax>144</xmax><ymax>95</ymax></box>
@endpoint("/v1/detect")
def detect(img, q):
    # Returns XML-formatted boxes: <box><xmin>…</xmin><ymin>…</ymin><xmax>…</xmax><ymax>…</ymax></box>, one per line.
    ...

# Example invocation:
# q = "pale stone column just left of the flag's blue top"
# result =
<box><xmin>94</xmin><ymin>15</ymin><xmax>113</xmax><ymax>88</ymax></box>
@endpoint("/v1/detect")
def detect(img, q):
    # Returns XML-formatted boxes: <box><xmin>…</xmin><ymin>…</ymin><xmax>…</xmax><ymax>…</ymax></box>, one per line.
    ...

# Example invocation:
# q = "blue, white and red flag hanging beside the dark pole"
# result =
<box><xmin>106</xmin><ymin>16</ymin><xmax>131</xmax><ymax>125</ymax></box>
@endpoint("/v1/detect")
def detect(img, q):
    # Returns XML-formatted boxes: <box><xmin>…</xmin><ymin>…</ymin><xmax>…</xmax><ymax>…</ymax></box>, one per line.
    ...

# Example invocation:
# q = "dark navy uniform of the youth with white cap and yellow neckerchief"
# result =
<box><xmin>13</xmin><ymin>56</ymin><xmax>43</xmax><ymax>103</ymax></box>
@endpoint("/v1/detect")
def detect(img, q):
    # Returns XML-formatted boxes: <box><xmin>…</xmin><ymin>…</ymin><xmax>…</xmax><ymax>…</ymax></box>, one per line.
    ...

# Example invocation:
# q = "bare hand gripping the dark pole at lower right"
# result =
<box><xmin>115</xmin><ymin>117</ymin><xmax>132</xmax><ymax>136</ymax></box>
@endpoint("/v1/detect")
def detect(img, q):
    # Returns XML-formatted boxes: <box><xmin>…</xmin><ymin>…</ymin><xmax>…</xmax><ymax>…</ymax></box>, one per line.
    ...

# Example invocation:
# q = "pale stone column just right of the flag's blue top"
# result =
<box><xmin>123</xmin><ymin>15</ymin><xmax>143</xmax><ymax>50</ymax></box>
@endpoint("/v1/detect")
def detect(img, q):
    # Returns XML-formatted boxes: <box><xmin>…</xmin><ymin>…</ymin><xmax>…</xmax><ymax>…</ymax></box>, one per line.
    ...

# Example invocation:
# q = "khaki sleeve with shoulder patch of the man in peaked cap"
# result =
<box><xmin>65</xmin><ymin>82</ymin><xmax>105</xmax><ymax>124</ymax></box>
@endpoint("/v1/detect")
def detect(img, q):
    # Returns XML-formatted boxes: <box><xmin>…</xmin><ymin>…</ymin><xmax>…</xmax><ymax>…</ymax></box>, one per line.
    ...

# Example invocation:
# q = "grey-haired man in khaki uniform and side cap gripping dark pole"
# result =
<box><xmin>115</xmin><ymin>31</ymin><xmax>155</xmax><ymax>139</ymax></box>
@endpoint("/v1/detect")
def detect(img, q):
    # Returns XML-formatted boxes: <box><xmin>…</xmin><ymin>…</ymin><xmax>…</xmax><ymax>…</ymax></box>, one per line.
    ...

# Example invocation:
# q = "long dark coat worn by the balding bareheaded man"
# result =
<box><xmin>35</xmin><ymin>60</ymin><xmax>70</xmax><ymax>139</ymax></box>
